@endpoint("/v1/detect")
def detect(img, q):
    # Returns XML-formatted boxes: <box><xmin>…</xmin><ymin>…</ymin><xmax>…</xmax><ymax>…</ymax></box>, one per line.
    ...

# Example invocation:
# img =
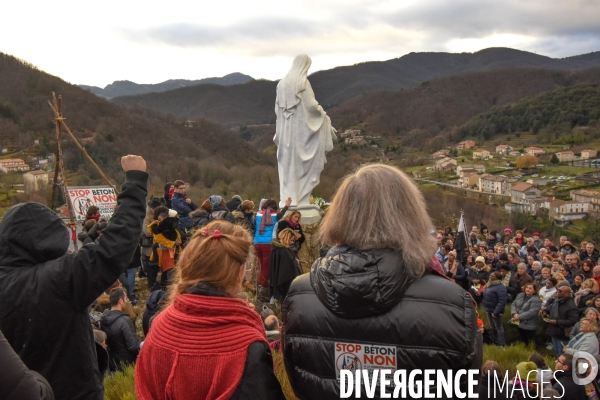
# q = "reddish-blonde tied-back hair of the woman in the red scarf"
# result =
<box><xmin>167</xmin><ymin>220</ymin><xmax>254</xmax><ymax>304</ymax></box>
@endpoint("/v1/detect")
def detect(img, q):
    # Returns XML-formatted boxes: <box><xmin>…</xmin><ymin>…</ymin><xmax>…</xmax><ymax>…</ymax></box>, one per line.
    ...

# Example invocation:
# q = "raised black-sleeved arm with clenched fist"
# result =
<box><xmin>48</xmin><ymin>155</ymin><xmax>148</xmax><ymax>310</ymax></box>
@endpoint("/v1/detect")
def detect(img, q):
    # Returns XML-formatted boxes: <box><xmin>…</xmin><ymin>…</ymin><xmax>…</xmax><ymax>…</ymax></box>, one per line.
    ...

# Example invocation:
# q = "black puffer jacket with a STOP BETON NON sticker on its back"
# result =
<box><xmin>282</xmin><ymin>246</ymin><xmax>482</xmax><ymax>399</ymax></box>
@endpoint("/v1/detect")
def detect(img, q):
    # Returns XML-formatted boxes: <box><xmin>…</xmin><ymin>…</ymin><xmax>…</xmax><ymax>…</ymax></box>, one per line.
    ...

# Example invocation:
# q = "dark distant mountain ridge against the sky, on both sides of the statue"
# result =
<box><xmin>112</xmin><ymin>48</ymin><xmax>600</xmax><ymax>127</ymax></box>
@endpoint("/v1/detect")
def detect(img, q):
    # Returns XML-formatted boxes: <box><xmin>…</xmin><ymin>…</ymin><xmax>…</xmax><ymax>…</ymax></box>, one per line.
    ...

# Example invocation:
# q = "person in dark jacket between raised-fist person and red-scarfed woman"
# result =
<box><xmin>101</xmin><ymin>288</ymin><xmax>140</xmax><ymax>372</ymax></box>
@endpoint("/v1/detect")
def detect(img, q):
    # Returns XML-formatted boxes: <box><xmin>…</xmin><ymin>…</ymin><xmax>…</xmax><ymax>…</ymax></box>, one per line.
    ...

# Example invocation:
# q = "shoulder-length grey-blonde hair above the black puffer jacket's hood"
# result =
<box><xmin>319</xmin><ymin>164</ymin><xmax>437</xmax><ymax>277</ymax></box>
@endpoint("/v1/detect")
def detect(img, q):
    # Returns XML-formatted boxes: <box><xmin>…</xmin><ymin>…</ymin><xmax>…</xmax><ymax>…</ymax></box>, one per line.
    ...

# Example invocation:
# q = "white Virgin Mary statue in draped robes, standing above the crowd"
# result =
<box><xmin>273</xmin><ymin>54</ymin><xmax>336</xmax><ymax>214</ymax></box>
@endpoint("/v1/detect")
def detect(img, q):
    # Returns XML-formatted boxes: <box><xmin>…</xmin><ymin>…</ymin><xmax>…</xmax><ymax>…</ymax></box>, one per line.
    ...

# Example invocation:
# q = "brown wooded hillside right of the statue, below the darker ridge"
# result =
<box><xmin>329</xmin><ymin>68</ymin><xmax>600</xmax><ymax>147</ymax></box>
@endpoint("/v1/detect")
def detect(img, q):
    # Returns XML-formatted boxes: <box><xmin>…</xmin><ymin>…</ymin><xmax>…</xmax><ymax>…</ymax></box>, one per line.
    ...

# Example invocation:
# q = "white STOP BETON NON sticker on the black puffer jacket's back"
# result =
<box><xmin>335</xmin><ymin>342</ymin><xmax>398</xmax><ymax>381</ymax></box>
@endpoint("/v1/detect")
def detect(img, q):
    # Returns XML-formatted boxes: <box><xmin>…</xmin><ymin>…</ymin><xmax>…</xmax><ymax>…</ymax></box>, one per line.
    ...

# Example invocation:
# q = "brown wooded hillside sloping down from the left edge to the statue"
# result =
<box><xmin>0</xmin><ymin>53</ymin><xmax>276</xmax><ymax>197</ymax></box>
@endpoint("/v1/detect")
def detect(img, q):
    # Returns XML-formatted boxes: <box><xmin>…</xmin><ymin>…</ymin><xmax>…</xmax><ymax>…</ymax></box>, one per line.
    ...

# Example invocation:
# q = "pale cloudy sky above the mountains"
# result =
<box><xmin>0</xmin><ymin>0</ymin><xmax>600</xmax><ymax>87</ymax></box>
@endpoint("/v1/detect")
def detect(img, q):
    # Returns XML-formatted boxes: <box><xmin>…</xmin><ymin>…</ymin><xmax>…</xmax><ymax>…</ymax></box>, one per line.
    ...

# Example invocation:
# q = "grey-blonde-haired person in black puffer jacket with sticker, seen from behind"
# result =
<box><xmin>282</xmin><ymin>164</ymin><xmax>482</xmax><ymax>399</ymax></box>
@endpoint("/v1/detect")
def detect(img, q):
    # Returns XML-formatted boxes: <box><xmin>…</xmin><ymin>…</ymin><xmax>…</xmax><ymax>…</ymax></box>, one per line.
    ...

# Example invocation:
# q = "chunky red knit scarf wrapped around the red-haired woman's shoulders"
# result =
<box><xmin>135</xmin><ymin>294</ymin><xmax>267</xmax><ymax>400</ymax></box>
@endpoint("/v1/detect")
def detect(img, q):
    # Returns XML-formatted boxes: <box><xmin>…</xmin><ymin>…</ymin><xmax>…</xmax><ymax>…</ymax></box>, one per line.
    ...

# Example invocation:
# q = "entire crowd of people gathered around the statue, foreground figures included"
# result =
<box><xmin>0</xmin><ymin>156</ymin><xmax>600</xmax><ymax>399</ymax></box>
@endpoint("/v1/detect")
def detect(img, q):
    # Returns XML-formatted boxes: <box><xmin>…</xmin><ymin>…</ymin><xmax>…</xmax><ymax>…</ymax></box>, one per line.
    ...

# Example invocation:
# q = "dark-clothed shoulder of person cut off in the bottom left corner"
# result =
<box><xmin>0</xmin><ymin>331</ymin><xmax>54</xmax><ymax>400</ymax></box>
